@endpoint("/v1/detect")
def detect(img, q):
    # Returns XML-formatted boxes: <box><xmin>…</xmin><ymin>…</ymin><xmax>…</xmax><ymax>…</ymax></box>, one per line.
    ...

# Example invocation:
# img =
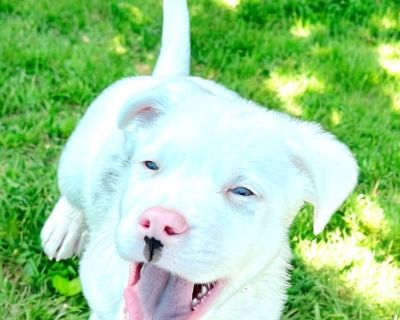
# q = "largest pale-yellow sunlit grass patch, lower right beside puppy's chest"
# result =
<box><xmin>297</xmin><ymin>234</ymin><xmax>400</xmax><ymax>307</ymax></box>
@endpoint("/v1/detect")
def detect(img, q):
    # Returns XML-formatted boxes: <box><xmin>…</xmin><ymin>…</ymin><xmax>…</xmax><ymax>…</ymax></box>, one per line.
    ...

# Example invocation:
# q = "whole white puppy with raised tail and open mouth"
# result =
<box><xmin>42</xmin><ymin>0</ymin><xmax>357</xmax><ymax>320</ymax></box>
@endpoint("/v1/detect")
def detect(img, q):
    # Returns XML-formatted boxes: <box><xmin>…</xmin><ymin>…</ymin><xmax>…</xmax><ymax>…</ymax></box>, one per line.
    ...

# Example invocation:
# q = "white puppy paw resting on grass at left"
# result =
<box><xmin>40</xmin><ymin>197</ymin><xmax>86</xmax><ymax>261</ymax></box>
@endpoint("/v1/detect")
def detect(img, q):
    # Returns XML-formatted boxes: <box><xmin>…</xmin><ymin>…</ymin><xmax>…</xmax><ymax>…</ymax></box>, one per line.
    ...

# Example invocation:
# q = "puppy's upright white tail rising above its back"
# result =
<box><xmin>153</xmin><ymin>0</ymin><xmax>190</xmax><ymax>77</ymax></box>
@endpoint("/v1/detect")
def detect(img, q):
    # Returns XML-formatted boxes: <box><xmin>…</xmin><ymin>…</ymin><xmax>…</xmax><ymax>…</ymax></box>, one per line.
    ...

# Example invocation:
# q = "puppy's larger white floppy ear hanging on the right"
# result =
<box><xmin>289</xmin><ymin>122</ymin><xmax>358</xmax><ymax>234</ymax></box>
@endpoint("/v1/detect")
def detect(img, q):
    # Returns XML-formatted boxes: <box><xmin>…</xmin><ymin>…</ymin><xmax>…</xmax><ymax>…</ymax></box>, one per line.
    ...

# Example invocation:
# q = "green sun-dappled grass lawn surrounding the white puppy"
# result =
<box><xmin>0</xmin><ymin>0</ymin><xmax>400</xmax><ymax>320</ymax></box>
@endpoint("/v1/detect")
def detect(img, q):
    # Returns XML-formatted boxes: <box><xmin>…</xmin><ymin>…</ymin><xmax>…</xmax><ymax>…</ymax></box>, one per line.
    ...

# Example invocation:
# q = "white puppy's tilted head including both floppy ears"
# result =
<box><xmin>116</xmin><ymin>80</ymin><xmax>357</xmax><ymax>283</ymax></box>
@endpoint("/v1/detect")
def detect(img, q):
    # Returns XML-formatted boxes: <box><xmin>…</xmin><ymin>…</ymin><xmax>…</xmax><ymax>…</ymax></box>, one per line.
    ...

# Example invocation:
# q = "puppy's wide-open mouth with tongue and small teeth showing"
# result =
<box><xmin>124</xmin><ymin>263</ymin><xmax>221</xmax><ymax>320</ymax></box>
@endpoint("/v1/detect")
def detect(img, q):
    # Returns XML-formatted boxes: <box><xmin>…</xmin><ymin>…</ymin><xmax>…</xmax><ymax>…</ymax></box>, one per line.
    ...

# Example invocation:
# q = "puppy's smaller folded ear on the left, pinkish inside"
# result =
<box><xmin>117</xmin><ymin>88</ymin><xmax>170</xmax><ymax>130</ymax></box>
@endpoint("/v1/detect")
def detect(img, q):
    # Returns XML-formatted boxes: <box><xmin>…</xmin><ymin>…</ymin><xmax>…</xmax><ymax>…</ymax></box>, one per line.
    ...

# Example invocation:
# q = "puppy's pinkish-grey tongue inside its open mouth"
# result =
<box><xmin>127</xmin><ymin>264</ymin><xmax>194</xmax><ymax>320</ymax></box>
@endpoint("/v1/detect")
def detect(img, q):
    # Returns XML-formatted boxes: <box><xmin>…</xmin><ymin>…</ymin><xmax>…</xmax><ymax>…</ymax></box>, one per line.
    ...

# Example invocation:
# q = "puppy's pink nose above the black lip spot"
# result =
<box><xmin>139</xmin><ymin>207</ymin><xmax>188</xmax><ymax>243</ymax></box>
